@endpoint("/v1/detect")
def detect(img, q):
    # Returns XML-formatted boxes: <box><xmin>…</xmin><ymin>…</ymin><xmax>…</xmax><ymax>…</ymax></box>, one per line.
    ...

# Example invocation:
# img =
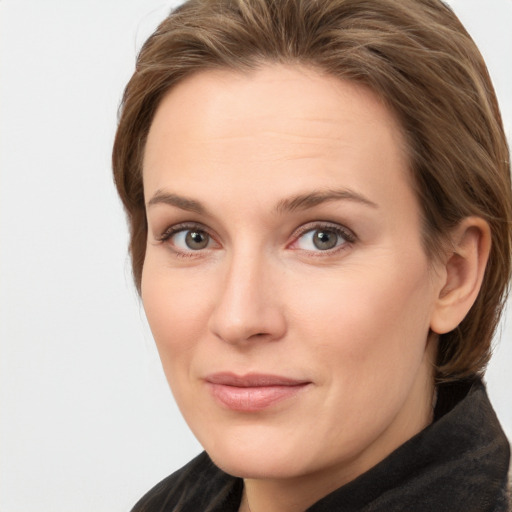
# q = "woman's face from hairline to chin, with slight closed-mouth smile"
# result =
<box><xmin>142</xmin><ymin>65</ymin><xmax>442</xmax><ymax>490</ymax></box>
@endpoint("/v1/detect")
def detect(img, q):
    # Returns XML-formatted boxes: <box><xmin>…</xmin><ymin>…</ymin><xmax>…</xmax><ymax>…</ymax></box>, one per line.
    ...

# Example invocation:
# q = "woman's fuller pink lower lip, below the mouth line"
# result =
<box><xmin>208</xmin><ymin>383</ymin><xmax>308</xmax><ymax>412</ymax></box>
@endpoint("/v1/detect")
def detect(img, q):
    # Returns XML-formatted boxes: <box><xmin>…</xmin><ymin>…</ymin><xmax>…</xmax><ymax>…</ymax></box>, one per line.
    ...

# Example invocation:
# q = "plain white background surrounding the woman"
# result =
<box><xmin>0</xmin><ymin>0</ymin><xmax>512</xmax><ymax>512</ymax></box>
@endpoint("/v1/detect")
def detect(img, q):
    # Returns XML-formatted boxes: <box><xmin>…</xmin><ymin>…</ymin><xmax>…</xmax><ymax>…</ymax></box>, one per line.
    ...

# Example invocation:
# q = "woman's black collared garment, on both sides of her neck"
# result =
<box><xmin>132</xmin><ymin>380</ymin><xmax>510</xmax><ymax>512</ymax></box>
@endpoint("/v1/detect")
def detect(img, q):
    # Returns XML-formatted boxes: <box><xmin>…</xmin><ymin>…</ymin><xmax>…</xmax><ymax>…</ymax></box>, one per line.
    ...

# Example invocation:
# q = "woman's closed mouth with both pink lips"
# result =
<box><xmin>205</xmin><ymin>373</ymin><xmax>311</xmax><ymax>412</ymax></box>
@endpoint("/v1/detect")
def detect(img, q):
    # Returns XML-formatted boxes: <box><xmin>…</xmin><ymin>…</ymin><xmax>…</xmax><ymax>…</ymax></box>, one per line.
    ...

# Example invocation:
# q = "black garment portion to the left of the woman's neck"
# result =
<box><xmin>131</xmin><ymin>452</ymin><xmax>242</xmax><ymax>512</ymax></box>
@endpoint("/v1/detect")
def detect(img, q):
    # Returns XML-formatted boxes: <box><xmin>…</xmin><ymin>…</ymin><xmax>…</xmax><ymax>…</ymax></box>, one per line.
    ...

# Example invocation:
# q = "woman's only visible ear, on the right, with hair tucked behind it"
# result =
<box><xmin>430</xmin><ymin>217</ymin><xmax>491</xmax><ymax>334</ymax></box>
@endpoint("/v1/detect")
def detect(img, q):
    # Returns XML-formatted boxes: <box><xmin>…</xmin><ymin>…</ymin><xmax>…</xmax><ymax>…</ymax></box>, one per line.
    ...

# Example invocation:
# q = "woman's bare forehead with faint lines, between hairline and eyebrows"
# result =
<box><xmin>143</xmin><ymin>65</ymin><xmax>409</xmax><ymax>206</ymax></box>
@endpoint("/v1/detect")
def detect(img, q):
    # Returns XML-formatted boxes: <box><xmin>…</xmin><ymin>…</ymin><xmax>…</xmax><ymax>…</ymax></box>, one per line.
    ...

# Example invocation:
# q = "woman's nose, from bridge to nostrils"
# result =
<box><xmin>209</xmin><ymin>254</ymin><xmax>286</xmax><ymax>344</ymax></box>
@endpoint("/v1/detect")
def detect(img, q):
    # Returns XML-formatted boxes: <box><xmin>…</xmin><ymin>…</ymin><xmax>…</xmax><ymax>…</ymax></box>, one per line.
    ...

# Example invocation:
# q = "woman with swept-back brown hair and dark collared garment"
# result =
<box><xmin>113</xmin><ymin>0</ymin><xmax>512</xmax><ymax>512</ymax></box>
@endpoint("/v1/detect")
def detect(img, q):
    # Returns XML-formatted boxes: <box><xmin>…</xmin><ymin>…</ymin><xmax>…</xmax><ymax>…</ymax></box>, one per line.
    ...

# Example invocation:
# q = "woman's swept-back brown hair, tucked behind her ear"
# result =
<box><xmin>113</xmin><ymin>0</ymin><xmax>512</xmax><ymax>380</ymax></box>
